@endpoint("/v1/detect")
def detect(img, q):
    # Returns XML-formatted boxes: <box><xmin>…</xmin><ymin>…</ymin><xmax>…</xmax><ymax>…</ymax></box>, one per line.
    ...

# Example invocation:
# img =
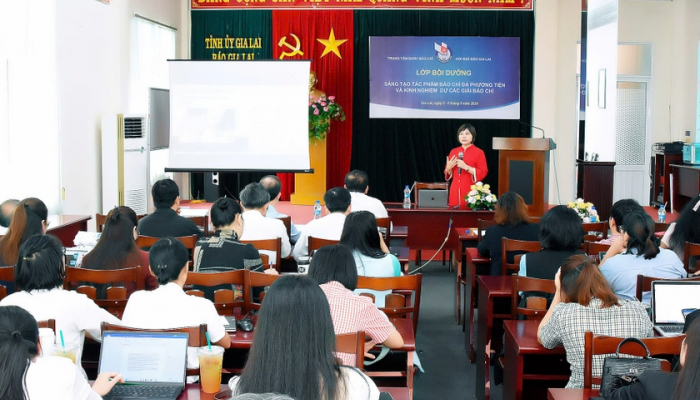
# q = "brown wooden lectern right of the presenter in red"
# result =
<box><xmin>493</xmin><ymin>137</ymin><xmax>555</xmax><ymax>216</ymax></box>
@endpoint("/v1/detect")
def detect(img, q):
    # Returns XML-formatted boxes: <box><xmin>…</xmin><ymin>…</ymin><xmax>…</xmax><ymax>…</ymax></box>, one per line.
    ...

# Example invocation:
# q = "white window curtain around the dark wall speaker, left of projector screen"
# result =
<box><xmin>130</xmin><ymin>17</ymin><xmax>176</xmax><ymax>183</ymax></box>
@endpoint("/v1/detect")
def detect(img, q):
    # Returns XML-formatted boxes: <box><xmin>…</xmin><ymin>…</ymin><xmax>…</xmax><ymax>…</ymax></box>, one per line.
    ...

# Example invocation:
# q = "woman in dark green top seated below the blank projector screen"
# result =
<box><xmin>194</xmin><ymin>197</ymin><xmax>268</xmax><ymax>301</ymax></box>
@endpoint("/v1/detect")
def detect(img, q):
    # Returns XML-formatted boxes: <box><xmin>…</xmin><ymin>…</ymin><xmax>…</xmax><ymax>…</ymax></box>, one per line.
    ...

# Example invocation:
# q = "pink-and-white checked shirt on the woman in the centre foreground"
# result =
<box><xmin>320</xmin><ymin>281</ymin><xmax>394</xmax><ymax>366</ymax></box>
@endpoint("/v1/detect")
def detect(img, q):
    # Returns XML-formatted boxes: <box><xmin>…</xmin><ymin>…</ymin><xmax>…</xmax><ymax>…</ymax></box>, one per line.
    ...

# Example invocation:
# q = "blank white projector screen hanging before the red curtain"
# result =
<box><xmin>166</xmin><ymin>60</ymin><xmax>311</xmax><ymax>172</ymax></box>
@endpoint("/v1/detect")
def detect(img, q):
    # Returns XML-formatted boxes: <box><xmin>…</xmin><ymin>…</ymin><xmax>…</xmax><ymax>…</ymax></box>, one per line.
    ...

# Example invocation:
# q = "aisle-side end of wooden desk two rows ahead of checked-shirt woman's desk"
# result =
<box><xmin>464</xmin><ymin>247</ymin><xmax>491</xmax><ymax>363</ymax></box>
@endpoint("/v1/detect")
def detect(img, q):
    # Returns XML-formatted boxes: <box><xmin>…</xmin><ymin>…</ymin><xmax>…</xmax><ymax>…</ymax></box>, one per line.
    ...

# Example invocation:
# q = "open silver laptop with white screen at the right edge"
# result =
<box><xmin>651</xmin><ymin>280</ymin><xmax>700</xmax><ymax>336</ymax></box>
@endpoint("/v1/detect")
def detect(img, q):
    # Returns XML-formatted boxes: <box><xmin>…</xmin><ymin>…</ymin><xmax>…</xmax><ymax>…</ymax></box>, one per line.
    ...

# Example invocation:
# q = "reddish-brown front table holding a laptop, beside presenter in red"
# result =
<box><xmin>385</xmin><ymin>203</ymin><xmax>493</xmax><ymax>266</ymax></box>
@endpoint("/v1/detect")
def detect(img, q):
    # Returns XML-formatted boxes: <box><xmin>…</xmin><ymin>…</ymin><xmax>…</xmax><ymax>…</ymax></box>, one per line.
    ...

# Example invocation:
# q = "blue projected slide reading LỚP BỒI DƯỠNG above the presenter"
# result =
<box><xmin>369</xmin><ymin>36</ymin><xmax>520</xmax><ymax>119</ymax></box>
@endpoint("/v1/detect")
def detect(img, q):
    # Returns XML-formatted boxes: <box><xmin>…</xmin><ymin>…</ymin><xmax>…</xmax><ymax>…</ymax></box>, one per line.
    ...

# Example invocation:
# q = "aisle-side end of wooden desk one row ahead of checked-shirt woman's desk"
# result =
<box><xmin>474</xmin><ymin>276</ymin><xmax>511</xmax><ymax>400</ymax></box>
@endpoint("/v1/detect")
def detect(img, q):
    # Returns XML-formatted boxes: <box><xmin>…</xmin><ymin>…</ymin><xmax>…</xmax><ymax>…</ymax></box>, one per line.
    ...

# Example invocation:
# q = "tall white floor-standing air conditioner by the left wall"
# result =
<box><xmin>102</xmin><ymin>114</ymin><xmax>150</xmax><ymax>214</ymax></box>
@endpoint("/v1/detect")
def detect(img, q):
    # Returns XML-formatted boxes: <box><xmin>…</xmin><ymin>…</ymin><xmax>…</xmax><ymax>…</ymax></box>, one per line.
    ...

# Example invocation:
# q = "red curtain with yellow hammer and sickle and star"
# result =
<box><xmin>272</xmin><ymin>10</ymin><xmax>355</xmax><ymax>198</ymax></box>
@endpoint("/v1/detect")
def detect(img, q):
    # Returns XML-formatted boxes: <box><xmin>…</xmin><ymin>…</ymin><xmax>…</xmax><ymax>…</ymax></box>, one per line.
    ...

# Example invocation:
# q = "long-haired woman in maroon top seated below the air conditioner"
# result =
<box><xmin>82</xmin><ymin>206</ymin><xmax>158</xmax><ymax>299</ymax></box>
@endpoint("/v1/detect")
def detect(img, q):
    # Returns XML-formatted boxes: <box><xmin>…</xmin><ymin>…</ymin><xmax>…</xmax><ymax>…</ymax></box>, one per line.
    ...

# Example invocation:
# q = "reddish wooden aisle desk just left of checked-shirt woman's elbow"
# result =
<box><xmin>503</xmin><ymin>320</ymin><xmax>568</xmax><ymax>400</ymax></box>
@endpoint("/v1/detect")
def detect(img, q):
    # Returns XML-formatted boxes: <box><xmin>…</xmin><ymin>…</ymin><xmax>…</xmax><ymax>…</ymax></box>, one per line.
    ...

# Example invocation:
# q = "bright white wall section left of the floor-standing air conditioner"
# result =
<box><xmin>56</xmin><ymin>0</ymin><xmax>190</xmax><ymax>225</ymax></box>
